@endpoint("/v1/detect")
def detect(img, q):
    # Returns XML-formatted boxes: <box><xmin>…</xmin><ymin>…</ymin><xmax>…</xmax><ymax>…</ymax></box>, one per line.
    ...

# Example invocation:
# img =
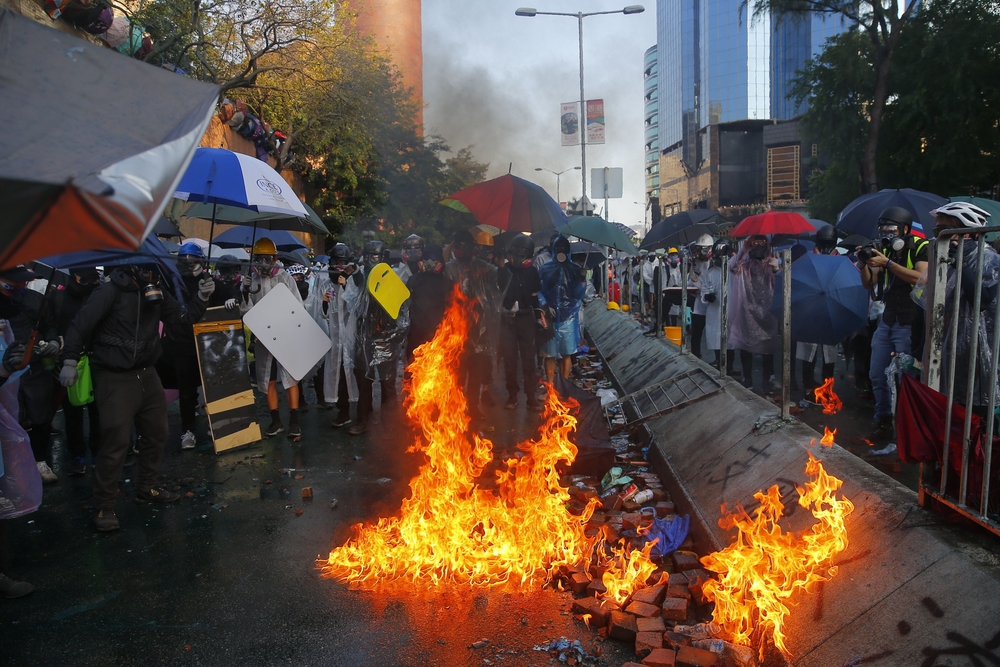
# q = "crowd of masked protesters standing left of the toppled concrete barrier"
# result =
<box><xmin>0</xmin><ymin>230</ymin><xmax>594</xmax><ymax>597</ymax></box>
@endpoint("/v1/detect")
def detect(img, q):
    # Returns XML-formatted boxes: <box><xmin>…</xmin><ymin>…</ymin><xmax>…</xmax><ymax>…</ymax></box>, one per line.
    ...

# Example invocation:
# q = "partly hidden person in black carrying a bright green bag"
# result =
<box><xmin>50</xmin><ymin>268</ymin><xmax>101</xmax><ymax>477</ymax></box>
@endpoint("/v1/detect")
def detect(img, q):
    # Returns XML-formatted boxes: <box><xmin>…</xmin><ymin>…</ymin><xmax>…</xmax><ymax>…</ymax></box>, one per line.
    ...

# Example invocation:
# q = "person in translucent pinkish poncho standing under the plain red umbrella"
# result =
<box><xmin>729</xmin><ymin>235</ymin><xmax>780</xmax><ymax>392</ymax></box>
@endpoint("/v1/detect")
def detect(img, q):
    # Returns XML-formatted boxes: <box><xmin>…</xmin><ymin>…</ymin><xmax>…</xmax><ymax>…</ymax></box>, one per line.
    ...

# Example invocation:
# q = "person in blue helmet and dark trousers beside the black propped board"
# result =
<box><xmin>166</xmin><ymin>241</ymin><xmax>239</xmax><ymax>449</ymax></box>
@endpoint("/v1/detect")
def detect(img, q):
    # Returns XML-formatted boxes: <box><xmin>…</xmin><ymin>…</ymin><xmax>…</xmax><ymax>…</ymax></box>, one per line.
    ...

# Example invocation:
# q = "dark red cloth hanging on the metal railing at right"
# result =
<box><xmin>896</xmin><ymin>374</ymin><xmax>983</xmax><ymax>470</ymax></box>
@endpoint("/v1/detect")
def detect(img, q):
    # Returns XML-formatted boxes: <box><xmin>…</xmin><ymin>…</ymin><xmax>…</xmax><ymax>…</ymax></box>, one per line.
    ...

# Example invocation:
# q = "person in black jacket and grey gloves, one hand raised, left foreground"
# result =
<box><xmin>59</xmin><ymin>265</ymin><xmax>215</xmax><ymax>532</ymax></box>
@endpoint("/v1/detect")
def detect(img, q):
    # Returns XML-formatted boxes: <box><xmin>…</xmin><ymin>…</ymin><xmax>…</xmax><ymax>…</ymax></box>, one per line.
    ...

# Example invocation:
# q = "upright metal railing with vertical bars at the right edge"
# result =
<box><xmin>918</xmin><ymin>227</ymin><xmax>1000</xmax><ymax>535</ymax></box>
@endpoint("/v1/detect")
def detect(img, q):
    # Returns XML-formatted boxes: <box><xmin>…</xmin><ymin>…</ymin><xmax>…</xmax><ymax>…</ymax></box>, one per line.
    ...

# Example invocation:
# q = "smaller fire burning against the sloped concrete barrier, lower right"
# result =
<box><xmin>702</xmin><ymin>453</ymin><xmax>854</xmax><ymax>657</ymax></box>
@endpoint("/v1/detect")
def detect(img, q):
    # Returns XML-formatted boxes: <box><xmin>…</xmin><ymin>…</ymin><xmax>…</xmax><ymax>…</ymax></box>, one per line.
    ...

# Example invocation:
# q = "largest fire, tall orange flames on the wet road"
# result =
<box><xmin>321</xmin><ymin>289</ymin><xmax>600</xmax><ymax>588</ymax></box>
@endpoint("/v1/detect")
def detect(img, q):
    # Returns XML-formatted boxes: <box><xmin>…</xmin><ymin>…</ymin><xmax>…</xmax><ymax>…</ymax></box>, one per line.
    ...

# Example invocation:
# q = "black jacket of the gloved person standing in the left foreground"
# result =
<box><xmin>63</xmin><ymin>269</ymin><xmax>208</xmax><ymax>372</ymax></box>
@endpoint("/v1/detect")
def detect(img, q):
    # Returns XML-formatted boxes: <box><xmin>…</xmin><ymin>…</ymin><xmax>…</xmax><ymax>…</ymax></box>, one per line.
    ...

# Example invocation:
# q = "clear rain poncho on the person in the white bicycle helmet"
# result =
<box><xmin>942</xmin><ymin>239</ymin><xmax>1000</xmax><ymax>406</ymax></box>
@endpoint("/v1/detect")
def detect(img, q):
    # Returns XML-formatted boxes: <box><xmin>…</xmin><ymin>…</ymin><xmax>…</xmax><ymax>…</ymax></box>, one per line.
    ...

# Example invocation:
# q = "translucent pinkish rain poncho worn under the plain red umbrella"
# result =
<box><xmin>729</xmin><ymin>243</ymin><xmax>778</xmax><ymax>354</ymax></box>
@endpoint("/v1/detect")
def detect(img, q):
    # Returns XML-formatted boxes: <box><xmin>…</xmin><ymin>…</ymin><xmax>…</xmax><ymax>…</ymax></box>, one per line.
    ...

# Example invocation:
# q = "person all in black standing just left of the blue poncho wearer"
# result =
<box><xmin>499</xmin><ymin>234</ymin><xmax>542</xmax><ymax>412</ymax></box>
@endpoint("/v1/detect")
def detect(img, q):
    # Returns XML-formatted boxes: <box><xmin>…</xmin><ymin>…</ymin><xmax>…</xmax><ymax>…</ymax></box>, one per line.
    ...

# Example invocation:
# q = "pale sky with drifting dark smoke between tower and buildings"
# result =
<box><xmin>423</xmin><ymin>0</ymin><xmax>656</xmax><ymax>235</ymax></box>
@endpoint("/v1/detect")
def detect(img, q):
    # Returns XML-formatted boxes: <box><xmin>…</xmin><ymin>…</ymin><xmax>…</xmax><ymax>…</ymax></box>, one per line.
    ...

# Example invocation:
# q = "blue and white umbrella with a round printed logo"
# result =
<box><xmin>174</xmin><ymin>148</ymin><xmax>309</xmax><ymax>218</ymax></box>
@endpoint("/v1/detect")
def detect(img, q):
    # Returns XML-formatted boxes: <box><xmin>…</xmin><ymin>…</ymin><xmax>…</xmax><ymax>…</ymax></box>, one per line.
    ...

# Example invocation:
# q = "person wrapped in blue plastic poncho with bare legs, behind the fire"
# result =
<box><xmin>538</xmin><ymin>234</ymin><xmax>586</xmax><ymax>383</ymax></box>
